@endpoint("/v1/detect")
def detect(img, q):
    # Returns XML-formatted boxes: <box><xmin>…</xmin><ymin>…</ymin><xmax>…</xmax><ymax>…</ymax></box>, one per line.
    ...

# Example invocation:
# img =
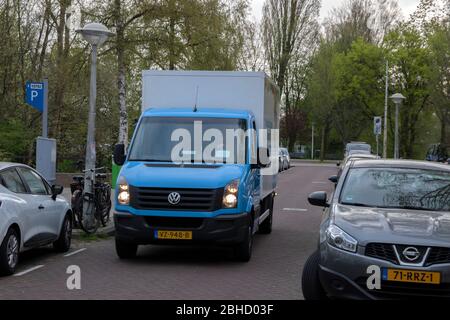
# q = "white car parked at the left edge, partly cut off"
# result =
<box><xmin>0</xmin><ymin>162</ymin><xmax>72</xmax><ymax>275</ymax></box>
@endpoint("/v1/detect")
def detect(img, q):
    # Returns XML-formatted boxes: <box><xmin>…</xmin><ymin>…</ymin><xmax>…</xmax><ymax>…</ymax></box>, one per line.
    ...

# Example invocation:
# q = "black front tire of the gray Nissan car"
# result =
<box><xmin>302</xmin><ymin>251</ymin><xmax>328</xmax><ymax>300</ymax></box>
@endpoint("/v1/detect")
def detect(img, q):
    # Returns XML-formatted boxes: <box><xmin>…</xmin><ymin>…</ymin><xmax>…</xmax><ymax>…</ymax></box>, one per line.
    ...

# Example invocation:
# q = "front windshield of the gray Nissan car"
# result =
<box><xmin>340</xmin><ymin>168</ymin><xmax>450</xmax><ymax>211</ymax></box>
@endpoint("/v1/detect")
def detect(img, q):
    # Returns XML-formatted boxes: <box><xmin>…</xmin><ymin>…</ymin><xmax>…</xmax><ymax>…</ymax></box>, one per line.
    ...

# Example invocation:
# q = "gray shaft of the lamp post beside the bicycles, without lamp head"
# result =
<box><xmin>83</xmin><ymin>45</ymin><xmax>97</xmax><ymax>222</ymax></box>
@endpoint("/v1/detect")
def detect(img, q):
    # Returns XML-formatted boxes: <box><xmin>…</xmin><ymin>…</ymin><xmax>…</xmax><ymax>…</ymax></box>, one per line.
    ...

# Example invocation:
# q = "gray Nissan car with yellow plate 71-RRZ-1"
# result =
<box><xmin>302</xmin><ymin>160</ymin><xmax>450</xmax><ymax>300</ymax></box>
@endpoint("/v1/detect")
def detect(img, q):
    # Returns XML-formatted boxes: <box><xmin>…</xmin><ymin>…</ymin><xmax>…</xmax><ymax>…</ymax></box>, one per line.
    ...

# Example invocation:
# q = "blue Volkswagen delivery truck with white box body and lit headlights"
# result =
<box><xmin>114</xmin><ymin>70</ymin><xmax>280</xmax><ymax>261</ymax></box>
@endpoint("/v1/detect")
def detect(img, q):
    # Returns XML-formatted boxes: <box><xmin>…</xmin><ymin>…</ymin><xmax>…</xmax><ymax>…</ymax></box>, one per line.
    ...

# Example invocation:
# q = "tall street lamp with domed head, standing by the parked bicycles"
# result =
<box><xmin>76</xmin><ymin>23</ymin><xmax>114</xmax><ymax>224</ymax></box>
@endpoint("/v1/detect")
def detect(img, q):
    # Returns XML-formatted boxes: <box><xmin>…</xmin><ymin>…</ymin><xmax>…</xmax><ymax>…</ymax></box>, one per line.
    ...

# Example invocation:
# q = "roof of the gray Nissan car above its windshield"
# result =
<box><xmin>351</xmin><ymin>159</ymin><xmax>450</xmax><ymax>172</ymax></box>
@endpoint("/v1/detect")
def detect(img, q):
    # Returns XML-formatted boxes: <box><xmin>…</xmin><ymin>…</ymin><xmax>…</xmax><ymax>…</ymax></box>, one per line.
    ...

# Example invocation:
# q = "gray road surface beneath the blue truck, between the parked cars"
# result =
<box><xmin>0</xmin><ymin>163</ymin><xmax>336</xmax><ymax>300</ymax></box>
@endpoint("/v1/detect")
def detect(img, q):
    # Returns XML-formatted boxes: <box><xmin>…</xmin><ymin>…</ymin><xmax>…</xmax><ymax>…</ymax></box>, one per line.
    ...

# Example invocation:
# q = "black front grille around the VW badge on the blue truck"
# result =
<box><xmin>130</xmin><ymin>186</ymin><xmax>223</xmax><ymax>211</ymax></box>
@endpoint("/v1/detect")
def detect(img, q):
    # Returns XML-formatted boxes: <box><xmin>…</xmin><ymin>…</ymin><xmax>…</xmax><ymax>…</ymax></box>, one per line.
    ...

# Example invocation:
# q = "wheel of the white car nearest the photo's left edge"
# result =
<box><xmin>0</xmin><ymin>228</ymin><xmax>20</xmax><ymax>276</ymax></box>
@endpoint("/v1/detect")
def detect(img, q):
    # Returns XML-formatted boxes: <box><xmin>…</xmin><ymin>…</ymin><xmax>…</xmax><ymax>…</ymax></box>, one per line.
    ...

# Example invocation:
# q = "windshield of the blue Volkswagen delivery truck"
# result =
<box><xmin>128</xmin><ymin>117</ymin><xmax>248</xmax><ymax>164</ymax></box>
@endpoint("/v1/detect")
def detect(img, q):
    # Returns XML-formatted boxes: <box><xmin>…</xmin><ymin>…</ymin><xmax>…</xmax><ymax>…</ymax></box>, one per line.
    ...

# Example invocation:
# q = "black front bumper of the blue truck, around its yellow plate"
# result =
<box><xmin>114</xmin><ymin>212</ymin><xmax>250</xmax><ymax>245</ymax></box>
